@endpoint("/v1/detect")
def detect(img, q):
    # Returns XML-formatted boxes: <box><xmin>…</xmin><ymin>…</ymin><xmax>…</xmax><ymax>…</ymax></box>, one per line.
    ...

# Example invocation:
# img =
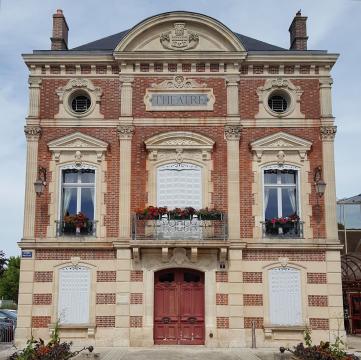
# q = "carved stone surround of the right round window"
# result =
<box><xmin>255</xmin><ymin>78</ymin><xmax>305</xmax><ymax>119</ymax></box>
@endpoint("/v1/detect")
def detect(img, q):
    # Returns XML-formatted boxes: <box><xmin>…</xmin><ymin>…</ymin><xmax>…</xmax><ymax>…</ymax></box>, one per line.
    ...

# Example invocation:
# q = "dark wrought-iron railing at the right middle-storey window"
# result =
<box><xmin>261</xmin><ymin>220</ymin><xmax>303</xmax><ymax>239</ymax></box>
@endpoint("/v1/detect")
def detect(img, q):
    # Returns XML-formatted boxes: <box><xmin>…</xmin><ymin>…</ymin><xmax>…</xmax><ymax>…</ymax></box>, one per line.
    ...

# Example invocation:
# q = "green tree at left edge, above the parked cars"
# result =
<box><xmin>0</xmin><ymin>256</ymin><xmax>20</xmax><ymax>303</ymax></box>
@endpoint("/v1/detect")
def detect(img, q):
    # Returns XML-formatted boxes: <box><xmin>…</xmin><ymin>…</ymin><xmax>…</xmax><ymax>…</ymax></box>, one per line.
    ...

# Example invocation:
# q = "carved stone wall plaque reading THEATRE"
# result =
<box><xmin>144</xmin><ymin>75</ymin><xmax>215</xmax><ymax>111</ymax></box>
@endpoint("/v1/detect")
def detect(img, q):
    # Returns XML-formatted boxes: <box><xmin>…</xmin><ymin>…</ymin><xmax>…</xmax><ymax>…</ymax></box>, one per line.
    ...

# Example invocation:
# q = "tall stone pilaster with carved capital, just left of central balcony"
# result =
<box><xmin>118</xmin><ymin>125</ymin><xmax>134</xmax><ymax>240</ymax></box>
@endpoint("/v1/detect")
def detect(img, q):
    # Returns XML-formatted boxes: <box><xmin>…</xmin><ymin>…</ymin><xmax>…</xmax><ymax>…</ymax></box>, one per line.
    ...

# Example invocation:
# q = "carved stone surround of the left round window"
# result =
<box><xmin>55</xmin><ymin>79</ymin><xmax>104</xmax><ymax>119</ymax></box>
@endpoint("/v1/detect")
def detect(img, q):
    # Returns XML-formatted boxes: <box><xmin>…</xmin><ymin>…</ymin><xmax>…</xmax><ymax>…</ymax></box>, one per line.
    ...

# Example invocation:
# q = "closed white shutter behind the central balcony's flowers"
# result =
<box><xmin>157</xmin><ymin>163</ymin><xmax>202</xmax><ymax>209</ymax></box>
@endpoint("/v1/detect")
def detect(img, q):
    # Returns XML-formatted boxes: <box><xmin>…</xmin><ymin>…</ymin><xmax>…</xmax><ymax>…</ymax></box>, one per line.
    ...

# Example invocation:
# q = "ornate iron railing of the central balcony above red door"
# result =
<box><xmin>132</xmin><ymin>214</ymin><xmax>228</xmax><ymax>241</ymax></box>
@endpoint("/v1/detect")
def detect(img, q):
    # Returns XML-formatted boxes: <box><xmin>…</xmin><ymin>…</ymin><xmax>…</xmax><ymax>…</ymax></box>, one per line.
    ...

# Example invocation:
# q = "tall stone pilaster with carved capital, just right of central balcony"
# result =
<box><xmin>224</xmin><ymin>125</ymin><xmax>242</xmax><ymax>240</ymax></box>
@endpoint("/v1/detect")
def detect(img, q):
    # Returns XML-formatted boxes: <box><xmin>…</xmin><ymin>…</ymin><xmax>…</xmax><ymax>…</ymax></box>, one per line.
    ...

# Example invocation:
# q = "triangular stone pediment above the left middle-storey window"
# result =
<box><xmin>48</xmin><ymin>132</ymin><xmax>108</xmax><ymax>152</ymax></box>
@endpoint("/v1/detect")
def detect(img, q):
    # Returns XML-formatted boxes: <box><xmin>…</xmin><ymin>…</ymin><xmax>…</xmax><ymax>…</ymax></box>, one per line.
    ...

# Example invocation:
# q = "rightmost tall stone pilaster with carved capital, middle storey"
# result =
<box><xmin>321</xmin><ymin>126</ymin><xmax>338</xmax><ymax>241</ymax></box>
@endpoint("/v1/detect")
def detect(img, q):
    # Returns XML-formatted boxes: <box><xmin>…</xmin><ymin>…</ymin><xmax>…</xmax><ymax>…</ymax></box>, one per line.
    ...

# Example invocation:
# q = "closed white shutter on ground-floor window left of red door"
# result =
<box><xmin>58</xmin><ymin>266</ymin><xmax>90</xmax><ymax>324</ymax></box>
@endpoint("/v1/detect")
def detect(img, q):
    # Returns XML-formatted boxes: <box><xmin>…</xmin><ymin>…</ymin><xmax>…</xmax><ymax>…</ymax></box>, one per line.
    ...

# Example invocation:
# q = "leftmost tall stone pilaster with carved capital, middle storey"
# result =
<box><xmin>23</xmin><ymin>126</ymin><xmax>41</xmax><ymax>239</ymax></box>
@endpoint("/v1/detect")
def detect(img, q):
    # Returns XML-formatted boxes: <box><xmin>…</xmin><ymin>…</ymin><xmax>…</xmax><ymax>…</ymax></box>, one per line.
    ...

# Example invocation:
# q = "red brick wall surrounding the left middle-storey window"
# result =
<box><xmin>35</xmin><ymin>128</ymin><xmax>119</xmax><ymax>237</ymax></box>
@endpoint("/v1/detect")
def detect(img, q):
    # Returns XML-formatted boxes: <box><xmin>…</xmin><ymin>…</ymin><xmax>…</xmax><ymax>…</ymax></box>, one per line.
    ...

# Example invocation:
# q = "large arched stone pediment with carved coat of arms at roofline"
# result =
<box><xmin>115</xmin><ymin>11</ymin><xmax>245</xmax><ymax>52</ymax></box>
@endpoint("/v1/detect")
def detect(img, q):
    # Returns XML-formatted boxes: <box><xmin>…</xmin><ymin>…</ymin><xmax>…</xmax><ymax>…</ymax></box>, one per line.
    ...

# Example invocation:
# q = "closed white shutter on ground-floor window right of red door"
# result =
<box><xmin>268</xmin><ymin>267</ymin><xmax>302</xmax><ymax>325</ymax></box>
